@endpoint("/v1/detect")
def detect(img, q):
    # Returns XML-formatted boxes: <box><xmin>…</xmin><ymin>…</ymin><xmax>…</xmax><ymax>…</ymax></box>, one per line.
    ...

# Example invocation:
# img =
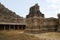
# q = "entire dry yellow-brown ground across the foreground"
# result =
<box><xmin>0</xmin><ymin>30</ymin><xmax>60</xmax><ymax>40</ymax></box>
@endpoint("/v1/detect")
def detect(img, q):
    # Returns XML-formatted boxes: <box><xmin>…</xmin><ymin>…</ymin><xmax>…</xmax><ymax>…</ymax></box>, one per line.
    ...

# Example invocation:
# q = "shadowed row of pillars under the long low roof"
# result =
<box><xmin>0</xmin><ymin>25</ymin><xmax>25</xmax><ymax>30</ymax></box>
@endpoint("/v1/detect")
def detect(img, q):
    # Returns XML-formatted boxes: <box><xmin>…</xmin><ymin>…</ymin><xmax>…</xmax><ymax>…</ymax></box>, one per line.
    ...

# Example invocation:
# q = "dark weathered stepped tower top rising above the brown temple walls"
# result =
<box><xmin>26</xmin><ymin>4</ymin><xmax>44</xmax><ymax>18</ymax></box>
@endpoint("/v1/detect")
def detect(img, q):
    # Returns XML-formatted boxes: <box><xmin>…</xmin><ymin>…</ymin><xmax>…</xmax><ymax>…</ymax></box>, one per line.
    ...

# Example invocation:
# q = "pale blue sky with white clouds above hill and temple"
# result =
<box><xmin>0</xmin><ymin>0</ymin><xmax>60</xmax><ymax>18</ymax></box>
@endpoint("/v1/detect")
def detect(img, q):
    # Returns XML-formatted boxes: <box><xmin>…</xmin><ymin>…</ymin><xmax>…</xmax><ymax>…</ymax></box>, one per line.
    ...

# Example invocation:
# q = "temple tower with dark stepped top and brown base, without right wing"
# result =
<box><xmin>26</xmin><ymin>4</ymin><xmax>44</xmax><ymax>33</ymax></box>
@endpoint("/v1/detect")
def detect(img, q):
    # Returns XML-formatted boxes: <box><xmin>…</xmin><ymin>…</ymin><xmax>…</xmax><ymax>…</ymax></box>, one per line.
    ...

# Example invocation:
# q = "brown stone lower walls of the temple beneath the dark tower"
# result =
<box><xmin>26</xmin><ymin>17</ymin><xmax>58</xmax><ymax>33</ymax></box>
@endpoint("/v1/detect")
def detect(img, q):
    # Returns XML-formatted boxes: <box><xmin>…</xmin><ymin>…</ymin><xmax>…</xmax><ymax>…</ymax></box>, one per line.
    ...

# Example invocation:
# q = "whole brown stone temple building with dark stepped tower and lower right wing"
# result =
<box><xmin>26</xmin><ymin>4</ymin><xmax>58</xmax><ymax>33</ymax></box>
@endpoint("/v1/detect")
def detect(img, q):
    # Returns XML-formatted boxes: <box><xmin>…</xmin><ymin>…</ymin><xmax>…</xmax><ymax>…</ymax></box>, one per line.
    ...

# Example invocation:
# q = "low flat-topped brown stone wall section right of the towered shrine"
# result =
<box><xmin>44</xmin><ymin>18</ymin><xmax>58</xmax><ymax>32</ymax></box>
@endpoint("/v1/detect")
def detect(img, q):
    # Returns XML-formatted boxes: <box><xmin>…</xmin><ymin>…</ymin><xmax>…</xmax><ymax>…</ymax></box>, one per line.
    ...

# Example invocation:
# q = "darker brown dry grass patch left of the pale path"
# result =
<box><xmin>0</xmin><ymin>30</ymin><xmax>40</xmax><ymax>40</ymax></box>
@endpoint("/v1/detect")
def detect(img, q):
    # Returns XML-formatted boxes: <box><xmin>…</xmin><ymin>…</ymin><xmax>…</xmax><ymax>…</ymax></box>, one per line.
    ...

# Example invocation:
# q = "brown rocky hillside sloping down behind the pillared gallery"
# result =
<box><xmin>0</xmin><ymin>3</ymin><xmax>23</xmax><ymax>23</ymax></box>
